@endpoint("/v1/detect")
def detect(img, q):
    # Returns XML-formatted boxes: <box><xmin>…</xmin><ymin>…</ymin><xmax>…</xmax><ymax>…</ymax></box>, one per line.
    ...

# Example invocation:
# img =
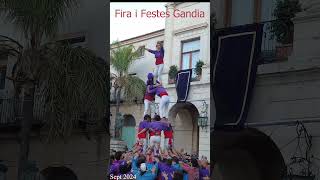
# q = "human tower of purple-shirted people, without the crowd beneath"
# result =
<box><xmin>137</xmin><ymin>42</ymin><xmax>173</xmax><ymax>154</ymax></box>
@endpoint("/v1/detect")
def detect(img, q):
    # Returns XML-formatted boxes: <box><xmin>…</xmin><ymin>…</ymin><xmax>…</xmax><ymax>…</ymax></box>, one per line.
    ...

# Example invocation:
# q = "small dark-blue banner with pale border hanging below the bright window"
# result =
<box><xmin>176</xmin><ymin>69</ymin><xmax>192</xmax><ymax>103</ymax></box>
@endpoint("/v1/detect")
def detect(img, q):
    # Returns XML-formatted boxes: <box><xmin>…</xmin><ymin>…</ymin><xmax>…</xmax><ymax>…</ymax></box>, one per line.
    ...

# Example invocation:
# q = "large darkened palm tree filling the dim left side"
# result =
<box><xmin>0</xmin><ymin>0</ymin><xmax>108</xmax><ymax>180</ymax></box>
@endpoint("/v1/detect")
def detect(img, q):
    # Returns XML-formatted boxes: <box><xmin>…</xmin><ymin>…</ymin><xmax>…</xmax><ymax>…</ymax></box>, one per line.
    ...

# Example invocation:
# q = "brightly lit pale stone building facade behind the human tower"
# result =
<box><xmin>110</xmin><ymin>3</ymin><xmax>210</xmax><ymax>158</ymax></box>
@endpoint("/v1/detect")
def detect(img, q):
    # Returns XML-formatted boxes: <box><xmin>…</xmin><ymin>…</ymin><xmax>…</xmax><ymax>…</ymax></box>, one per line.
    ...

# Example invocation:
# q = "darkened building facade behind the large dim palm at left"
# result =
<box><xmin>0</xmin><ymin>0</ymin><xmax>109</xmax><ymax>180</ymax></box>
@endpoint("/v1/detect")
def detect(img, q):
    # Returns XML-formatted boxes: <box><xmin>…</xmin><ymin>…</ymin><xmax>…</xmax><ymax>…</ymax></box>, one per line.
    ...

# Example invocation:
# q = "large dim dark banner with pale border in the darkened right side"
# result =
<box><xmin>211</xmin><ymin>24</ymin><xmax>263</xmax><ymax>129</ymax></box>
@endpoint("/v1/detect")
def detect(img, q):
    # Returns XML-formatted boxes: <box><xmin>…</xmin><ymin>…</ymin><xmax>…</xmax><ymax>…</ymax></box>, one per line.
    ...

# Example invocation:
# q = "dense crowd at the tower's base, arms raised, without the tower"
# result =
<box><xmin>109</xmin><ymin>136</ymin><xmax>210</xmax><ymax>180</ymax></box>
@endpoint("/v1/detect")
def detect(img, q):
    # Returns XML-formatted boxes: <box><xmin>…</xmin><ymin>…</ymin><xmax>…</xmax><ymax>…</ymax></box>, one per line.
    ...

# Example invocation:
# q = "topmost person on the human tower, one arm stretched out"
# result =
<box><xmin>145</xmin><ymin>42</ymin><xmax>164</xmax><ymax>83</ymax></box>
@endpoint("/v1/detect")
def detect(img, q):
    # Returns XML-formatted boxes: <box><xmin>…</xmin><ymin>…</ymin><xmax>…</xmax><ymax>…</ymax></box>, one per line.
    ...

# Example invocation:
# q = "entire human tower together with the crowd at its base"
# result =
<box><xmin>108</xmin><ymin>43</ymin><xmax>210</xmax><ymax>180</ymax></box>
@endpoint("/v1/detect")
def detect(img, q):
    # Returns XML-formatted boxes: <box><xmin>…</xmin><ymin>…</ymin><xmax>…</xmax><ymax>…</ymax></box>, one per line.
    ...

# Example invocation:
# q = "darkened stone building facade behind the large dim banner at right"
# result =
<box><xmin>211</xmin><ymin>0</ymin><xmax>320</xmax><ymax>180</ymax></box>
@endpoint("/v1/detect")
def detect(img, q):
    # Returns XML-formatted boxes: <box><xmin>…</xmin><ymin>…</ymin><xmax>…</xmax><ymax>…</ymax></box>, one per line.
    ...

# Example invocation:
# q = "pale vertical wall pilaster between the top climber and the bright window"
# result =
<box><xmin>164</xmin><ymin>3</ymin><xmax>174</xmax><ymax>76</ymax></box>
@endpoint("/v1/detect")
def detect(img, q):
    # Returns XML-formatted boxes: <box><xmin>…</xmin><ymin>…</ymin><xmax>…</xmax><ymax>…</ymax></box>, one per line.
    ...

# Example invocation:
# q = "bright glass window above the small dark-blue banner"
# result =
<box><xmin>181</xmin><ymin>39</ymin><xmax>200</xmax><ymax>78</ymax></box>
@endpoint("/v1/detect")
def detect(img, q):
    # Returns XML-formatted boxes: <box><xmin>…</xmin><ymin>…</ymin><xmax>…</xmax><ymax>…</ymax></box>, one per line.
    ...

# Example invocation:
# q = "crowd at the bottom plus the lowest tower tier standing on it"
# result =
<box><xmin>109</xmin><ymin>114</ymin><xmax>210</xmax><ymax>180</ymax></box>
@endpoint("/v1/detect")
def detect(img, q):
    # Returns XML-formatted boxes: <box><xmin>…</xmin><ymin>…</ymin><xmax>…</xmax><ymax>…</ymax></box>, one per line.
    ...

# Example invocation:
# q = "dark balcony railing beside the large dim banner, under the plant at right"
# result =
<box><xmin>216</xmin><ymin>20</ymin><xmax>293</xmax><ymax>64</ymax></box>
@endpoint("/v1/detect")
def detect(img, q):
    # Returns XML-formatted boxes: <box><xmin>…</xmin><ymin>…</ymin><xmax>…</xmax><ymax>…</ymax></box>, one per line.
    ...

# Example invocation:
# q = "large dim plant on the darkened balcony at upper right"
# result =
<box><xmin>270</xmin><ymin>0</ymin><xmax>302</xmax><ymax>44</ymax></box>
